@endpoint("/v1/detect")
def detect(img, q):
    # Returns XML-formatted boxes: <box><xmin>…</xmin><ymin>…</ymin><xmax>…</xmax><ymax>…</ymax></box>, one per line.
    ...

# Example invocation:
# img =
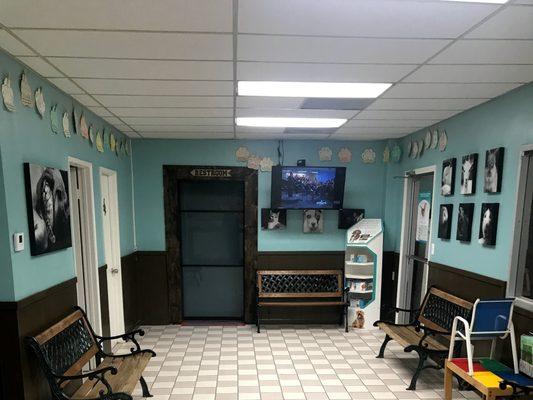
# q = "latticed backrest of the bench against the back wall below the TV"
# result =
<box><xmin>257</xmin><ymin>269</ymin><xmax>343</xmax><ymax>298</ymax></box>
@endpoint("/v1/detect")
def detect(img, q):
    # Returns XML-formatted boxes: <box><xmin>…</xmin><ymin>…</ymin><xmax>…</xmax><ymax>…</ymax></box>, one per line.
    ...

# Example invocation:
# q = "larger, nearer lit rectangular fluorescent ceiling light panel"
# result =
<box><xmin>237</xmin><ymin>81</ymin><xmax>392</xmax><ymax>99</ymax></box>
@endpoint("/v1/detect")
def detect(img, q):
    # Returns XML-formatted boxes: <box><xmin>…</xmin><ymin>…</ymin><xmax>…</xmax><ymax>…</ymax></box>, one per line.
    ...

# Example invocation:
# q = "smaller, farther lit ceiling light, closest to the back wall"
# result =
<box><xmin>235</xmin><ymin>117</ymin><xmax>347</xmax><ymax>128</ymax></box>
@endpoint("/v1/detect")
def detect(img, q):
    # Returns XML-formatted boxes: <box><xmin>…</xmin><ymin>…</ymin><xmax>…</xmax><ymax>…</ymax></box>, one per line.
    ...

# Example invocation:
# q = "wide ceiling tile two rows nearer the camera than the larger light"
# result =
<box><xmin>237</xmin><ymin>35</ymin><xmax>450</xmax><ymax>64</ymax></box>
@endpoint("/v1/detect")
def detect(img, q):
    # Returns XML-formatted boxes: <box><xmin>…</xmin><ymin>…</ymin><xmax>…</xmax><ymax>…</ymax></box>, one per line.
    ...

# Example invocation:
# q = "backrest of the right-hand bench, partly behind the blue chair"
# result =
<box><xmin>418</xmin><ymin>287</ymin><xmax>473</xmax><ymax>332</ymax></box>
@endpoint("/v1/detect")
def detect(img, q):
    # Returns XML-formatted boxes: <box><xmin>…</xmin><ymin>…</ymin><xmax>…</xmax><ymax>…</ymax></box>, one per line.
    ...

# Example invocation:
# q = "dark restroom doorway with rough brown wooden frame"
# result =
<box><xmin>163</xmin><ymin>165</ymin><xmax>258</xmax><ymax>323</ymax></box>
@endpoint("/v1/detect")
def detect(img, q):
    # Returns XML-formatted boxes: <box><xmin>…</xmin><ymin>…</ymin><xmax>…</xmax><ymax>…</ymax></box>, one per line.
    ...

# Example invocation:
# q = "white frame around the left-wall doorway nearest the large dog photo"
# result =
<box><xmin>68</xmin><ymin>157</ymin><xmax>102</xmax><ymax>335</ymax></box>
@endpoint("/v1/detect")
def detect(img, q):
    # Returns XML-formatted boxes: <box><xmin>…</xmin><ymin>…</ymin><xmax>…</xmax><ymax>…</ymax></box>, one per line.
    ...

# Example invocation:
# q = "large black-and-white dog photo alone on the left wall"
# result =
<box><xmin>24</xmin><ymin>163</ymin><xmax>72</xmax><ymax>256</ymax></box>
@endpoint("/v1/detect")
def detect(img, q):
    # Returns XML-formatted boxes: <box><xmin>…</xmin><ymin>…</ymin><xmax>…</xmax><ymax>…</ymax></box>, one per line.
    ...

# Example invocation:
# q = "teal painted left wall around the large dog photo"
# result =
<box><xmin>0</xmin><ymin>53</ymin><xmax>133</xmax><ymax>300</ymax></box>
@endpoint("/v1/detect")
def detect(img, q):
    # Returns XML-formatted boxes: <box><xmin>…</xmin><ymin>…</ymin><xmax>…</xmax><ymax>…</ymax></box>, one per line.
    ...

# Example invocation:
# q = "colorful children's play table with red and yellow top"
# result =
<box><xmin>444</xmin><ymin>358</ymin><xmax>533</xmax><ymax>400</ymax></box>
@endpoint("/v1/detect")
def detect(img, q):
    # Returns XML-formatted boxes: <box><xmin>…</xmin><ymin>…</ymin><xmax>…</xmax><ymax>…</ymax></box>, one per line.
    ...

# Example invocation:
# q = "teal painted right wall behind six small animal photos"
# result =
<box><xmin>385</xmin><ymin>84</ymin><xmax>533</xmax><ymax>280</ymax></box>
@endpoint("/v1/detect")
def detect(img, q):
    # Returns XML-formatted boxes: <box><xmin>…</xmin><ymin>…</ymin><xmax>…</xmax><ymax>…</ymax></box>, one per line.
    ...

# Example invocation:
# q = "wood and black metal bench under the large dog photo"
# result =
<box><xmin>26</xmin><ymin>308</ymin><xmax>155</xmax><ymax>400</ymax></box>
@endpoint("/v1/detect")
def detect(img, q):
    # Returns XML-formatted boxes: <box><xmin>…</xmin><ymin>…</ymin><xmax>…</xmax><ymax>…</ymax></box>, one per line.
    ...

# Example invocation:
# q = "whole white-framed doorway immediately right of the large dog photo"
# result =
<box><xmin>68</xmin><ymin>157</ymin><xmax>102</xmax><ymax>334</ymax></box>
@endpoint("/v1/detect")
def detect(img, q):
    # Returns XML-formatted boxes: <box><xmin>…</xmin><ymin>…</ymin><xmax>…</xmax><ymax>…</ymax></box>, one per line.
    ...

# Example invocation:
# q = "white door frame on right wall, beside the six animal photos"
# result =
<box><xmin>396</xmin><ymin>165</ymin><xmax>437</xmax><ymax>322</ymax></box>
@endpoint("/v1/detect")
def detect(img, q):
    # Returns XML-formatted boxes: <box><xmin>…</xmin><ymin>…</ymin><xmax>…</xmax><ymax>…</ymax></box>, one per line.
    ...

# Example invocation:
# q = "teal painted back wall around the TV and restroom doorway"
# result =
<box><xmin>133</xmin><ymin>140</ymin><xmax>386</xmax><ymax>251</ymax></box>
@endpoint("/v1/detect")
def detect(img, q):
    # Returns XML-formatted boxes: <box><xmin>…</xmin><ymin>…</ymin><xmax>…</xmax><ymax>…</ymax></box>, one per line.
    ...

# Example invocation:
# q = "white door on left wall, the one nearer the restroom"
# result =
<box><xmin>100</xmin><ymin>168</ymin><xmax>124</xmax><ymax>336</ymax></box>
